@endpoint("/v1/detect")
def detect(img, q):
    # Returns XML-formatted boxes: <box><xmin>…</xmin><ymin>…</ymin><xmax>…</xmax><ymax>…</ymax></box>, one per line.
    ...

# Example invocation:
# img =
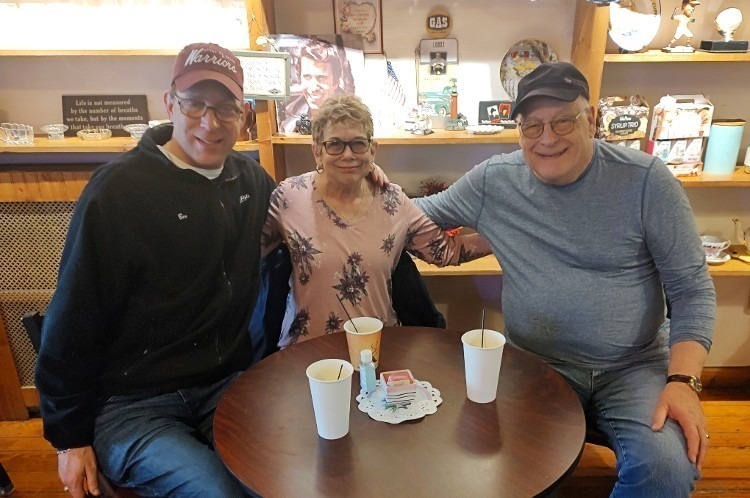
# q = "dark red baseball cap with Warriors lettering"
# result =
<box><xmin>172</xmin><ymin>43</ymin><xmax>244</xmax><ymax>100</ymax></box>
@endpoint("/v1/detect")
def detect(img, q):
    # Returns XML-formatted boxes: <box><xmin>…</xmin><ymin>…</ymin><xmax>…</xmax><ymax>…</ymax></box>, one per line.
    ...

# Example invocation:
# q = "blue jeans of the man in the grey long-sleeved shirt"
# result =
<box><xmin>551</xmin><ymin>359</ymin><xmax>700</xmax><ymax>498</ymax></box>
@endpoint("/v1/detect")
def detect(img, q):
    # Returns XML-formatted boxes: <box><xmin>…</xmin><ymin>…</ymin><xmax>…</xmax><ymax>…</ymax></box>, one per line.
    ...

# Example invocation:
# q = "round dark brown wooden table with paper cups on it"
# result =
<box><xmin>214</xmin><ymin>327</ymin><xmax>585</xmax><ymax>498</ymax></box>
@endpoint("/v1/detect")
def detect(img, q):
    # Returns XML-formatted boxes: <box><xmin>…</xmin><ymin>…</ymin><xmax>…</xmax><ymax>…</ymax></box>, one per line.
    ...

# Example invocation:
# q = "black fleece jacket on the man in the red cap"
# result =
<box><xmin>35</xmin><ymin>125</ymin><xmax>274</xmax><ymax>448</ymax></box>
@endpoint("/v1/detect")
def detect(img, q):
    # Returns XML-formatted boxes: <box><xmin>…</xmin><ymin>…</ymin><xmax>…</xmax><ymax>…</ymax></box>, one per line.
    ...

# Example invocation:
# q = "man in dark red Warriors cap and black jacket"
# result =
<box><xmin>36</xmin><ymin>43</ymin><xmax>274</xmax><ymax>498</ymax></box>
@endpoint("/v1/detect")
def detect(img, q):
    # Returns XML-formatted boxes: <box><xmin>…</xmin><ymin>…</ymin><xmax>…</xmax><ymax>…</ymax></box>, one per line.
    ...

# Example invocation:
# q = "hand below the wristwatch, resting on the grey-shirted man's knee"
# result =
<box><xmin>651</xmin><ymin>382</ymin><xmax>710</xmax><ymax>470</ymax></box>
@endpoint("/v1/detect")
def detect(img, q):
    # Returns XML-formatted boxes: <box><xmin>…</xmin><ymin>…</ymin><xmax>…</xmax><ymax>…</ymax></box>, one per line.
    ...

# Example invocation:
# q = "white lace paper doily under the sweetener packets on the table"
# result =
<box><xmin>356</xmin><ymin>380</ymin><xmax>443</xmax><ymax>424</ymax></box>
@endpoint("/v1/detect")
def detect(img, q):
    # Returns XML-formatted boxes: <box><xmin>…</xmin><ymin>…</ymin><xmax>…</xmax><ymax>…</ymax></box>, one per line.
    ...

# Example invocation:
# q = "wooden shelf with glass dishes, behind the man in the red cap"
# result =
<box><xmin>0</xmin><ymin>136</ymin><xmax>258</xmax><ymax>154</ymax></box>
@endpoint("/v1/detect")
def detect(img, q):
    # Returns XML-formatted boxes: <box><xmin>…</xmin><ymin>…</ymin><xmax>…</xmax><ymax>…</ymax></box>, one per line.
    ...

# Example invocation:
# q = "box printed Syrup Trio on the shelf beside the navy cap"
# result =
<box><xmin>596</xmin><ymin>95</ymin><xmax>649</xmax><ymax>142</ymax></box>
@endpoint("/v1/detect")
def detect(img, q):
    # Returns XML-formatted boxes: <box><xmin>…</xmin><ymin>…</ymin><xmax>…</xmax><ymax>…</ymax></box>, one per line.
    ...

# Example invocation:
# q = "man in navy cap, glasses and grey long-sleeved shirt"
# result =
<box><xmin>417</xmin><ymin>62</ymin><xmax>715</xmax><ymax>497</ymax></box>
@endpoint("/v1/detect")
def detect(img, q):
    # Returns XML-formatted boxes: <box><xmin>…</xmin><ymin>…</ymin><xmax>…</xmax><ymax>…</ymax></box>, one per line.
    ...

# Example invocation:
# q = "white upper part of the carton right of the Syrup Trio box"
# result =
<box><xmin>649</xmin><ymin>94</ymin><xmax>714</xmax><ymax>140</ymax></box>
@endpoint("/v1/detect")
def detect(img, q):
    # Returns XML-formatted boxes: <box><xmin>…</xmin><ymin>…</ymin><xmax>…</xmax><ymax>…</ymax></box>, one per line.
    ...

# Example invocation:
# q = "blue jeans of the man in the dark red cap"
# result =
<box><xmin>94</xmin><ymin>373</ymin><xmax>245</xmax><ymax>498</ymax></box>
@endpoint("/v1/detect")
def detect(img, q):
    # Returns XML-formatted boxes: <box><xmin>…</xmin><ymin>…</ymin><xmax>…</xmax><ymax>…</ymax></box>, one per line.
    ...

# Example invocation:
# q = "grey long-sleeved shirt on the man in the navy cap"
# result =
<box><xmin>417</xmin><ymin>140</ymin><xmax>716</xmax><ymax>369</ymax></box>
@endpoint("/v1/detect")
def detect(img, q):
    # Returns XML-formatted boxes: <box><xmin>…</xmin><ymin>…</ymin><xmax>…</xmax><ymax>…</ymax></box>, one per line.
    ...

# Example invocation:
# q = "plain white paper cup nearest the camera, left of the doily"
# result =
<box><xmin>306</xmin><ymin>359</ymin><xmax>354</xmax><ymax>439</ymax></box>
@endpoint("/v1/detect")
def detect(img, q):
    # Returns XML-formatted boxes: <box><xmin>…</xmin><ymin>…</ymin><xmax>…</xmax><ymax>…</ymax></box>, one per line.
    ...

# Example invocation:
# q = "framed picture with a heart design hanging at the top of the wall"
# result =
<box><xmin>333</xmin><ymin>0</ymin><xmax>383</xmax><ymax>54</ymax></box>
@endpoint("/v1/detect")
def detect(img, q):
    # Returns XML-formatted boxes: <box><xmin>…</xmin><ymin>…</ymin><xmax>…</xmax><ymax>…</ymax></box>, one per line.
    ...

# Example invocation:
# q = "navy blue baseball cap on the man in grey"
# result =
<box><xmin>510</xmin><ymin>62</ymin><xmax>589</xmax><ymax>119</ymax></box>
